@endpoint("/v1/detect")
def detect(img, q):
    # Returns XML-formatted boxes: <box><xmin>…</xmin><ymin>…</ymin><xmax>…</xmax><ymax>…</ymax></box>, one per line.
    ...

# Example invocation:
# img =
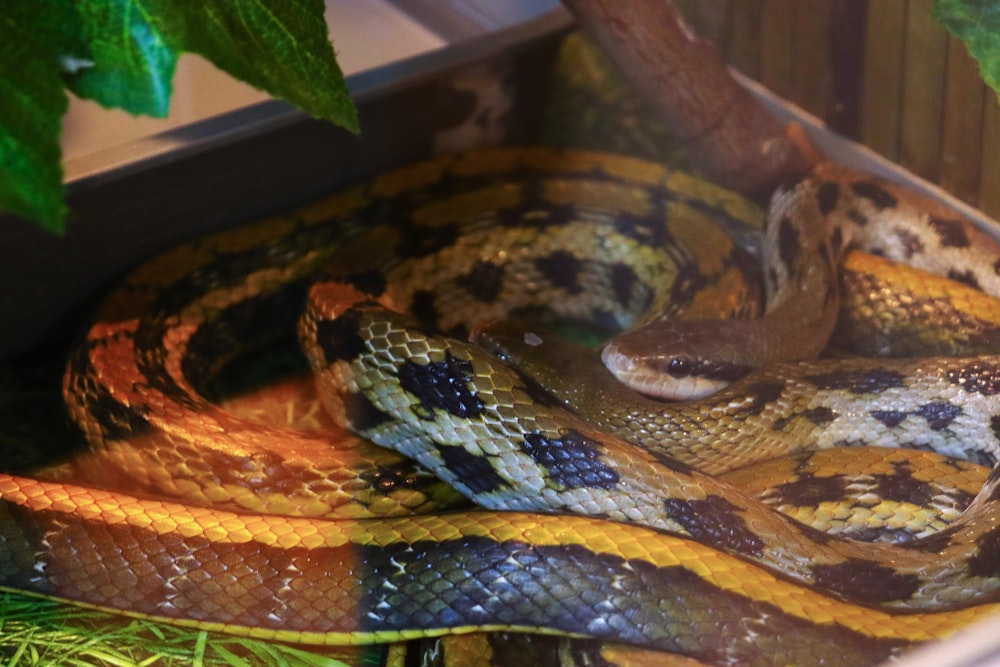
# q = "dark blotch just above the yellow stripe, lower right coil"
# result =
<box><xmin>812</xmin><ymin>558</ymin><xmax>920</xmax><ymax>605</ymax></box>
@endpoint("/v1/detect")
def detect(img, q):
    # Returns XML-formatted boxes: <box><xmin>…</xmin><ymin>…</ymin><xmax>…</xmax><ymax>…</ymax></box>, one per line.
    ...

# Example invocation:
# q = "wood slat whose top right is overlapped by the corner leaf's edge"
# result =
<box><xmin>899</xmin><ymin>0</ymin><xmax>948</xmax><ymax>181</ymax></box>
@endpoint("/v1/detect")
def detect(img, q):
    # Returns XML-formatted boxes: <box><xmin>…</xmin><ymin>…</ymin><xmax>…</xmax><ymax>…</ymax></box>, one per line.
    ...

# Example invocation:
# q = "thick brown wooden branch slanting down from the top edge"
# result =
<box><xmin>564</xmin><ymin>0</ymin><xmax>821</xmax><ymax>199</ymax></box>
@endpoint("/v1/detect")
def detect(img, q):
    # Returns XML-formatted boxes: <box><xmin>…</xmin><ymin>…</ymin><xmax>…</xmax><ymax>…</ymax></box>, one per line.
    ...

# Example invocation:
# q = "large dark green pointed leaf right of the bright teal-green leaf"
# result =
<box><xmin>143</xmin><ymin>0</ymin><xmax>358</xmax><ymax>132</ymax></box>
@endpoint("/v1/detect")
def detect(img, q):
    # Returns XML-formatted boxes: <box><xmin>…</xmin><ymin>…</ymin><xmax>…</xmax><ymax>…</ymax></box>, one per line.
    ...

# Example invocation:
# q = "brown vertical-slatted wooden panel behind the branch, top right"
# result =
<box><xmin>678</xmin><ymin>0</ymin><xmax>1000</xmax><ymax>218</ymax></box>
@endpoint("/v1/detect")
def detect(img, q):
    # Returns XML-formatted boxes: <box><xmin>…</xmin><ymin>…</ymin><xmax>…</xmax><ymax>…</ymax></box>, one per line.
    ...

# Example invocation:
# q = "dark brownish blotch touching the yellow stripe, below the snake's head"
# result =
<box><xmin>663</xmin><ymin>496</ymin><xmax>767</xmax><ymax>558</ymax></box>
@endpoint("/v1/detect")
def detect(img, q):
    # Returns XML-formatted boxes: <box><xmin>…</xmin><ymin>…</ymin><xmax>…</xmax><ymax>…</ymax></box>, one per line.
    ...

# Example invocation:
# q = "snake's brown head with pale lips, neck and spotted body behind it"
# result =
<box><xmin>602</xmin><ymin>163</ymin><xmax>1000</xmax><ymax>399</ymax></box>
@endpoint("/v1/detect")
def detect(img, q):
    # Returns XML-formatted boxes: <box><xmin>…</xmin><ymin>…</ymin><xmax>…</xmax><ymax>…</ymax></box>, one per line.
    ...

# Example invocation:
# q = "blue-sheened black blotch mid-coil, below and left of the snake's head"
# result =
<box><xmin>521</xmin><ymin>429</ymin><xmax>620</xmax><ymax>489</ymax></box>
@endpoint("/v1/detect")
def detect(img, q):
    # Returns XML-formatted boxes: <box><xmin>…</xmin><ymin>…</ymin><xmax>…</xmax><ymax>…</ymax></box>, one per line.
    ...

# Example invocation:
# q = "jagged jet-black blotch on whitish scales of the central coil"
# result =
<box><xmin>397</xmin><ymin>351</ymin><xmax>483</xmax><ymax>420</ymax></box>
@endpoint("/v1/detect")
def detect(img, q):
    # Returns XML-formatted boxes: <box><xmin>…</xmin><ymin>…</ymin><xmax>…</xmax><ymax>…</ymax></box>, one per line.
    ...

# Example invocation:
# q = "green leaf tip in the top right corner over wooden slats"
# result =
<box><xmin>933</xmin><ymin>0</ymin><xmax>1000</xmax><ymax>92</ymax></box>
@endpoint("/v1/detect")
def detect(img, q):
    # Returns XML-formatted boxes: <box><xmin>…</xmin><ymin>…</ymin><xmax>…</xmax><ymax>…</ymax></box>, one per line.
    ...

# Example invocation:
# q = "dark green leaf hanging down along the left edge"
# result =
<box><xmin>0</xmin><ymin>8</ymin><xmax>69</xmax><ymax>233</ymax></box>
